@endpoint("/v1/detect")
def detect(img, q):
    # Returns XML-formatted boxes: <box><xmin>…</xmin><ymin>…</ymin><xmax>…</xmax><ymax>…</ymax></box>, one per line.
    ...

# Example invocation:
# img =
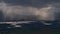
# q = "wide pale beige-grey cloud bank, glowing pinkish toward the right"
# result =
<box><xmin>0</xmin><ymin>2</ymin><xmax>59</xmax><ymax>20</ymax></box>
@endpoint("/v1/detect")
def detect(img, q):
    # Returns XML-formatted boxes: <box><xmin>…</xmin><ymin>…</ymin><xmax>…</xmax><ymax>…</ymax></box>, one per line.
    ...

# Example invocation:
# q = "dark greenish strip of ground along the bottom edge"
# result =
<box><xmin>0</xmin><ymin>28</ymin><xmax>60</xmax><ymax>34</ymax></box>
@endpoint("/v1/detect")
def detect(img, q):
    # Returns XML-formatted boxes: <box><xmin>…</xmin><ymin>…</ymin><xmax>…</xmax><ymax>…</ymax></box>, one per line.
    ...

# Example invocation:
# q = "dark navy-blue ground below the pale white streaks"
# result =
<box><xmin>0</xmin><ymin>22</ymin><xmax>60</xmax><ymax>34</ymax></box>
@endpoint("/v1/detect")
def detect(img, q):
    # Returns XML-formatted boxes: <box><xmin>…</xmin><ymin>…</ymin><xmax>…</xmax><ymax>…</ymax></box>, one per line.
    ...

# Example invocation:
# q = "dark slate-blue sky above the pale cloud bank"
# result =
<box><xmin>4</xmin><ymin>0</ymin><xmax>60</xmax><ymax>8</ymax></box>
